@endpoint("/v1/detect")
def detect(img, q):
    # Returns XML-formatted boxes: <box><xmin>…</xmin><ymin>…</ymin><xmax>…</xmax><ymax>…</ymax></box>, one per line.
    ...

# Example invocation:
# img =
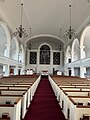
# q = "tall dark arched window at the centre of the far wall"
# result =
<box><xmin>40</xmin><ymin>45</ymin><xmax>50</xmax><ymax>64</ymax></box>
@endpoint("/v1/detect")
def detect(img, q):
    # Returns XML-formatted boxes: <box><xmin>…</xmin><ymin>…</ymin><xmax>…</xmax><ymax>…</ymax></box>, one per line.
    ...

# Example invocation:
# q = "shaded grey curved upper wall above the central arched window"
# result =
<box><xmin>26</xmin><ymin>35</ymin><xmax>63</xmax><ymax>50</ymax></box>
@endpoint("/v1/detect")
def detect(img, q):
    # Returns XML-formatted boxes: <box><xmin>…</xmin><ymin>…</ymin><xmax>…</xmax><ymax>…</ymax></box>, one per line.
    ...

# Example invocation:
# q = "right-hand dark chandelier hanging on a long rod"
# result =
<box><xmin>64</xmin><ymin>5</ymin><xmax>77</xmax><ymax>39</ymax></box>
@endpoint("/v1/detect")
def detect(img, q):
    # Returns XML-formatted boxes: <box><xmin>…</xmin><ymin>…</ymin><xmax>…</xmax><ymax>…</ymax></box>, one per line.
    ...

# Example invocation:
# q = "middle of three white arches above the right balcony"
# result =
<box><xmin>71</xmin><ymin>39</ymin><xmax>80</xmax><ymax>62</ymax></box>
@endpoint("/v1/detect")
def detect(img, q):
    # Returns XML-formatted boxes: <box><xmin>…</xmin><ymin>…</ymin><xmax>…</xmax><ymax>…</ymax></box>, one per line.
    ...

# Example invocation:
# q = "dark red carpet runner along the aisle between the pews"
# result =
<box><xmin>24</xmin><ymin>77</ymin><xmax>65</xmax><ymax>120</ymax></box>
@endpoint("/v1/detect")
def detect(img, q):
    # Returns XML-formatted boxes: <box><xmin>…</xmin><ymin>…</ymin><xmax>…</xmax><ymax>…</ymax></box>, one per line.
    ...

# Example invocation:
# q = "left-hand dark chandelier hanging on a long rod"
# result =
<box><xmin>14</xmin><ymin>4</ymin><xmax>28</xmax><ymax>38</ymax></box>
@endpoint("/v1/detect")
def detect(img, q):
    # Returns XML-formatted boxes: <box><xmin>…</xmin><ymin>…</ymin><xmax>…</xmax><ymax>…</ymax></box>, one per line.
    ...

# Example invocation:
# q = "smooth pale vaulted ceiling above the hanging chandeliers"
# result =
<box><xmin>0</xmin><ymin>0</ymin><xmax>90</xmax><ymax>42</ymax></box>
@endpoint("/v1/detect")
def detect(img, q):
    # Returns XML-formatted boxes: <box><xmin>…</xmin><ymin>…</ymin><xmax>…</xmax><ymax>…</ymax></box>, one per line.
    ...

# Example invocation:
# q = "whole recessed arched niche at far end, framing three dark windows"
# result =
<box><xmin>26</xmin><ymin>36</ymin><xmax>63</xmax><ymax>74</ymax></box>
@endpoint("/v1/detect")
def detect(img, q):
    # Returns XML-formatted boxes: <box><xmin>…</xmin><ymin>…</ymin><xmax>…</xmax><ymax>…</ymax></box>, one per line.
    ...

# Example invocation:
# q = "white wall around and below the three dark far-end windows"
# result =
<box><xmin>27</xmin><ymin>50</ymin><xmax>63</xmax><ymax>74</ymax></box>
